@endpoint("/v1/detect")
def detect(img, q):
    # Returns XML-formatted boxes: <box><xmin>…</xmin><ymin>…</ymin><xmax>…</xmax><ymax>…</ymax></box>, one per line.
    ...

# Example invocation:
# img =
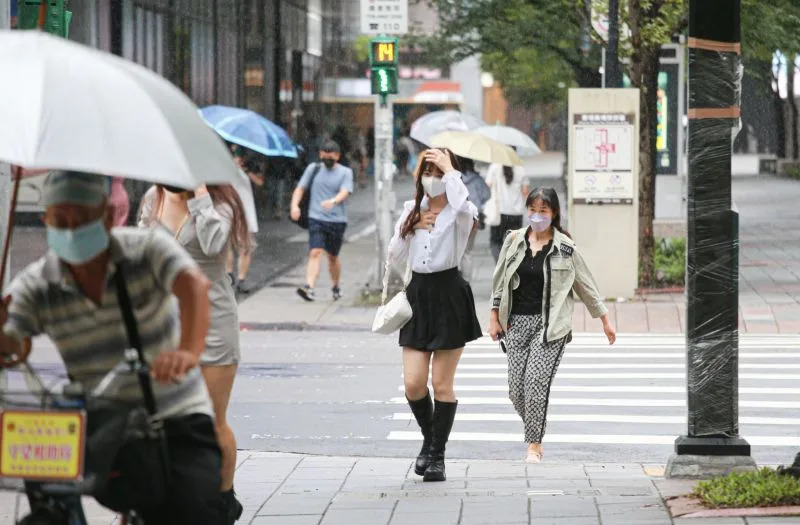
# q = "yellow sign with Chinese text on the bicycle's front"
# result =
<box><xmin>0</xmin><ymin>410</ymin><xmax>86</xmax><ymax>480</ymax></box>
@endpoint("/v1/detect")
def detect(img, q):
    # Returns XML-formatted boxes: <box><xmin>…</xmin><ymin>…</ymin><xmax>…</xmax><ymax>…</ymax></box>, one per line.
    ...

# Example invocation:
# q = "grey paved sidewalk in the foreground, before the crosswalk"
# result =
<box><xmin>0</xmin><ymin>449</ymin><xmax>800</xmax><ymax>525</ymax></box>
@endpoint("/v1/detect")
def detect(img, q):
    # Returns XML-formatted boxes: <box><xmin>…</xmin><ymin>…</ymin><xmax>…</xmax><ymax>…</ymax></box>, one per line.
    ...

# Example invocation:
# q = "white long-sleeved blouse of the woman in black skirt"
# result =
<box><xmin>389</xmin><ymin>170</ymin><xmax>478</xmax><ymax>273</ymax></box>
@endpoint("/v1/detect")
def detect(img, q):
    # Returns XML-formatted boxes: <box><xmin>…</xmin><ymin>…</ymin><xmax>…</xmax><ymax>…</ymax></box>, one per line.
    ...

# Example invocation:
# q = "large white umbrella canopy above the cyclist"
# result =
<box><xmin>0</xmin><ymin>31</ymin><xmax>238</xmax><ymax>188</ymax></box>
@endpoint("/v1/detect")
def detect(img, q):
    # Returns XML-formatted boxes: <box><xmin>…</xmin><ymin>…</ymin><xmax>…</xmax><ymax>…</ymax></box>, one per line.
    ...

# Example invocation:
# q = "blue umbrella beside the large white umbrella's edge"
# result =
<box><xmin>200</xmin><ymin>106</ymin><xmax>297</xmax><ymax>159</ymax></box>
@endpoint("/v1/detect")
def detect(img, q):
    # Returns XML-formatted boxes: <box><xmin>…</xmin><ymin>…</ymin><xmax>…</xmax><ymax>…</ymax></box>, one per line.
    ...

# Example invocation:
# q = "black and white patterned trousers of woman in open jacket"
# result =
<box><xmin>506</xmin><ymin>315</ymin><xmax>566</xmax><ymax>443</ymax></box>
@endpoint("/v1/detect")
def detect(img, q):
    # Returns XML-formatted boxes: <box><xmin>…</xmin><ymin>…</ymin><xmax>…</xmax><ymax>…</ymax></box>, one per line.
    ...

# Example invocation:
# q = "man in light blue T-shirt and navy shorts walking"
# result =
<box><xmin>291</xmin><ymin>140</ymin><xmax>353</xmax><ymax>301</ymax></box>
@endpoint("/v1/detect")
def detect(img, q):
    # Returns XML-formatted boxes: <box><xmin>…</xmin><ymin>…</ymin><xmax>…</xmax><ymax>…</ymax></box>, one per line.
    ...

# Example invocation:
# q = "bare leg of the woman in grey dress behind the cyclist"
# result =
<box><xmin>202</xmin><ymin>365</ymin><xmax>238</xmax><ymax>492</ymax></box>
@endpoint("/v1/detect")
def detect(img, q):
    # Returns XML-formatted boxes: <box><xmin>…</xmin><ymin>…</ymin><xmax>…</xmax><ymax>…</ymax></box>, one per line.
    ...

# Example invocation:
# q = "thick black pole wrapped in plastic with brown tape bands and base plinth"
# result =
<box><xmin>666</xmin><ymin>0</ymin><xmax>755</xmax><ymax>477</ymax></box>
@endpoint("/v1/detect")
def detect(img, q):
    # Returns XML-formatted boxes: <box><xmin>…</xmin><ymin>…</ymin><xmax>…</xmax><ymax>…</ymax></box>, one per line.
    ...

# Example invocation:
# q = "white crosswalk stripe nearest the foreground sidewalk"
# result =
<box><xmin>388</xmin><ymin>430</ymin><xmax>800</xmax><ymax>447</ymax></box>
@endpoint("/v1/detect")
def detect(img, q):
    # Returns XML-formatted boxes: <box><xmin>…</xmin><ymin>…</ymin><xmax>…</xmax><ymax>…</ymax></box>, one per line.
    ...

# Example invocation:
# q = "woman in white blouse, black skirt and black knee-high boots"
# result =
<box><xmin>389</xmin><ymin>149</ymin><xmax>481</xmax><ymax>481</ymax></box>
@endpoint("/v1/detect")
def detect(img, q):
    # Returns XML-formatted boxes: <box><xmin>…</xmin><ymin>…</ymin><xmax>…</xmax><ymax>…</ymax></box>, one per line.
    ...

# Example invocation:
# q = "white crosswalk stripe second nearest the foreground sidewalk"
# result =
<box><xmin>392</xmin><ymin>412</ymin><xmax>800</xmax><ymax>426</ymax></box>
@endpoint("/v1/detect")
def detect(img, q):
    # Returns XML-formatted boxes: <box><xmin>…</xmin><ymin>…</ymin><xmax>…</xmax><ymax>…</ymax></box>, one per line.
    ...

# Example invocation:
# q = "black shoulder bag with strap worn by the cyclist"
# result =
<box><xmin>86</xmin><ymin>265</ymin><xmax>170</xmax><ymax>512</ymax></box>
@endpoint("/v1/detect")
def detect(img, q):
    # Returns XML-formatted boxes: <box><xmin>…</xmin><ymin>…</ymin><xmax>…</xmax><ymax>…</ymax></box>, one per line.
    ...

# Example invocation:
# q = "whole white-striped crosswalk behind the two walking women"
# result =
<box><xmin>387</xmin><ymin>334</ymin><xmax>800</xmax><ymax>447</ymax></box>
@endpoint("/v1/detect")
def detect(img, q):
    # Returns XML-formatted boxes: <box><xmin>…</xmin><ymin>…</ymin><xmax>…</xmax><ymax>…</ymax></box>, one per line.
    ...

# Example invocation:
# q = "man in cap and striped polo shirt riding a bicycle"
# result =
<box><xmin>0</xmin><ymin>171</ymin><xmax>227</xmax><ymax>525</ymax></box>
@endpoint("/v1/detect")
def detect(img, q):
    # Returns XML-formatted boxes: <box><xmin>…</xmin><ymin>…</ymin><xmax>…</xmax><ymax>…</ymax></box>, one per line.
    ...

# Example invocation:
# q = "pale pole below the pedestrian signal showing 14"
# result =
<box><xmin>374</xmin><ymin>95</ymin><xmax>395</xmax><ymax>289</ymax></box>
